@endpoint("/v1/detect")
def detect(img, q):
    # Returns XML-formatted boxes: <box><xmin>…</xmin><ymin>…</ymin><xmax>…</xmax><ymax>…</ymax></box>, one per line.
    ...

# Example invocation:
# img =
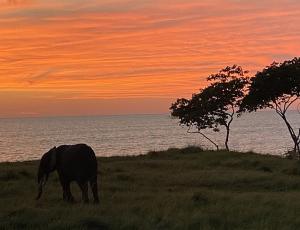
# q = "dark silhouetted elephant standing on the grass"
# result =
<box><xmin>36</xmin><ymin>144</ymin><xmax>99</xmax><ymax>203</ymax></box>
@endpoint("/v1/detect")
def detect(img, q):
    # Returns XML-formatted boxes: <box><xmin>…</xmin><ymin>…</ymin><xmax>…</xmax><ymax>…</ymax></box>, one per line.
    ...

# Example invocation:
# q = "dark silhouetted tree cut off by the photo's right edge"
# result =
<box><xmin>239</xmin><ymin>58</ymin><xmax>300</xmax><ymax>154</ymax></box>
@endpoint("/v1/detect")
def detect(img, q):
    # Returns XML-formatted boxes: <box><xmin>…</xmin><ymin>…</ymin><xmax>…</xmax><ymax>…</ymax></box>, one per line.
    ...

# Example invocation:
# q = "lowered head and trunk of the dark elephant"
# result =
<box><xmin>36</xmin><ymin>147</ymin><xmax>56</xmax><ymax>200</ymax></box>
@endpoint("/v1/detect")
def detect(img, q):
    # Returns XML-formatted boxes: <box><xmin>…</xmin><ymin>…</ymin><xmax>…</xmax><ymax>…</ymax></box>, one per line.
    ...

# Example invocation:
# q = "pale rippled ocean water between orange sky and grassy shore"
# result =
<box><xmin>0</xmin><ymin>111</ymin><xmax>300</xmax><ymax>162</ymax></box>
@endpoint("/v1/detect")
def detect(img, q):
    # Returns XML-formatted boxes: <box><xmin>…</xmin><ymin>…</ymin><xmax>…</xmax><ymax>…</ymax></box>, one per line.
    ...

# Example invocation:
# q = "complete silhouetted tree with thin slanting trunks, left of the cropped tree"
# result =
<box><xmin>170</xmin><ymin>65</ymin><xmax>248</xmax><ymax>150</ymax></box>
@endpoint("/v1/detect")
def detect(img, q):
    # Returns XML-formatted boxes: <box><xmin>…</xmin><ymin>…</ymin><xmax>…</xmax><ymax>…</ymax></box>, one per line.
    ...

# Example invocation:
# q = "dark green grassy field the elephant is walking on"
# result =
<box><xmin>0</xmin><ymin>147</ymin><xmax>300</xmax><ymax>230</ymax></box>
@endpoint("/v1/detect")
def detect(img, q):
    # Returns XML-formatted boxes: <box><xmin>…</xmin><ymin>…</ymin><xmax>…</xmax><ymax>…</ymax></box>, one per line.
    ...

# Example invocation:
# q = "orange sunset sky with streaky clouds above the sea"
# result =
<box><xmin>0</xmin><ymin>0</ymin><xmax>300</xmax><ymax>117</ymax></box>
